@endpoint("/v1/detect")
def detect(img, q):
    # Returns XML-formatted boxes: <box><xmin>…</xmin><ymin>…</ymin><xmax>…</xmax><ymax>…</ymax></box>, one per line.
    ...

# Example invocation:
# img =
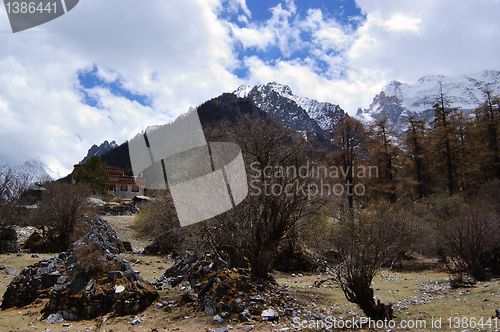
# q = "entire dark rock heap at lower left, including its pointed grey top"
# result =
<box><xmin>1</xmin><ymin>217</ymin><xmax>158</xmax><ymax>320</ymax></box>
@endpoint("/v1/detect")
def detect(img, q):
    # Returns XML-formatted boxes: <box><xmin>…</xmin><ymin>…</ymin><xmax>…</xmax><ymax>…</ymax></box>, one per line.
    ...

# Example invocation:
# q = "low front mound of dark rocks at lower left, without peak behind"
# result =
<box><xmin>1</xmin><ymin>252</ymin><xmax>158</xmax><ymax>320</ymax></box>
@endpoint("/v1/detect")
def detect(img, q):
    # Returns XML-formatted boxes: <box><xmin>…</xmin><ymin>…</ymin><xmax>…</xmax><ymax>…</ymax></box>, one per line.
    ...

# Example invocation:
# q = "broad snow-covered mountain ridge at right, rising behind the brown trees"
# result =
<box><xmin>356</xmin><ymin>70</ymin><xmax>500</xmax><ymax>126</ymax></box>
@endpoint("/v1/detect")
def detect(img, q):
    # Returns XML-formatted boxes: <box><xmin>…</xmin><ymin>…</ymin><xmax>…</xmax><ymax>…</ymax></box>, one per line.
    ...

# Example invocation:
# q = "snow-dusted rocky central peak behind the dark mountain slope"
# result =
<box><xmin>233</xmin><ymin>82</ymin><xmax>345</xmax><ymax>137</ymax></box>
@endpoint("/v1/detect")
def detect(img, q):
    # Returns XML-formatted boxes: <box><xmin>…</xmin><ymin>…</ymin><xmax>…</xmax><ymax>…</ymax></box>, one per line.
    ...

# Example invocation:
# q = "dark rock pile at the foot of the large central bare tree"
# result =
<box><xmin>155</xmin><ymin>253</ymin><xmax>300</xmax><ymax>322</ymax></box>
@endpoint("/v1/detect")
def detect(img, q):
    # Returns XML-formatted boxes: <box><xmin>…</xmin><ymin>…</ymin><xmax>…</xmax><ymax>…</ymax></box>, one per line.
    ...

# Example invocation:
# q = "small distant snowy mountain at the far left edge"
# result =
<box><xmin>0</xmin><ymin>160</ymin><xmax>57</xmax><ymax>197</ymax></box>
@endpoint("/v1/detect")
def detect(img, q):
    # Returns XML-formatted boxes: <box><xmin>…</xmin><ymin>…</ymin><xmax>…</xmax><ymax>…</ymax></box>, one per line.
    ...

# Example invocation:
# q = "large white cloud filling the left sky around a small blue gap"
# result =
<box><xmin>0</xmin><ymin>0</ymin><xmax>244</xmax><ymax>175</ymax></box>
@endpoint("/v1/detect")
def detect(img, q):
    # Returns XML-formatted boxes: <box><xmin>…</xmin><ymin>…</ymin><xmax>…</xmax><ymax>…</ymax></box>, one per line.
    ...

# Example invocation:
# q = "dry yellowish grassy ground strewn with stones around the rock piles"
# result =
<box><xmin>0</xmin><ymin>217</ymin><xmax>500</xmax><ymax>332</ymax></box>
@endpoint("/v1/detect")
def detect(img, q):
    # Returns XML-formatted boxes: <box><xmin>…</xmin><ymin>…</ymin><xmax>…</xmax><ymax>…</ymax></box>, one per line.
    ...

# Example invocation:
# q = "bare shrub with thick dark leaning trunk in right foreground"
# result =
<box><xmin>333</xmin><ymin>204</ymin><xmax>416</xmax><ymax>320</ymax></box>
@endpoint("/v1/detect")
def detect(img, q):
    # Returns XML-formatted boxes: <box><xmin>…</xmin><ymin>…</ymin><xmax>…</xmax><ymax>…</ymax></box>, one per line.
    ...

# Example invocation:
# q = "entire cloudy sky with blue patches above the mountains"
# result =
<box><xmin>0</xmin><ymin>0</ymin><xmax>500</xmax><ymax>175</ymax></box>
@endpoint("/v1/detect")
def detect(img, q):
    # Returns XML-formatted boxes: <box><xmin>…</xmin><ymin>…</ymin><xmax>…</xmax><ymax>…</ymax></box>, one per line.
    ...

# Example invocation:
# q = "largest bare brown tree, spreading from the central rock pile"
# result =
<box><xmin>205</xmin><ymin>116</ymin><xmax>322</xmax><ymax>279</ymax></box>
